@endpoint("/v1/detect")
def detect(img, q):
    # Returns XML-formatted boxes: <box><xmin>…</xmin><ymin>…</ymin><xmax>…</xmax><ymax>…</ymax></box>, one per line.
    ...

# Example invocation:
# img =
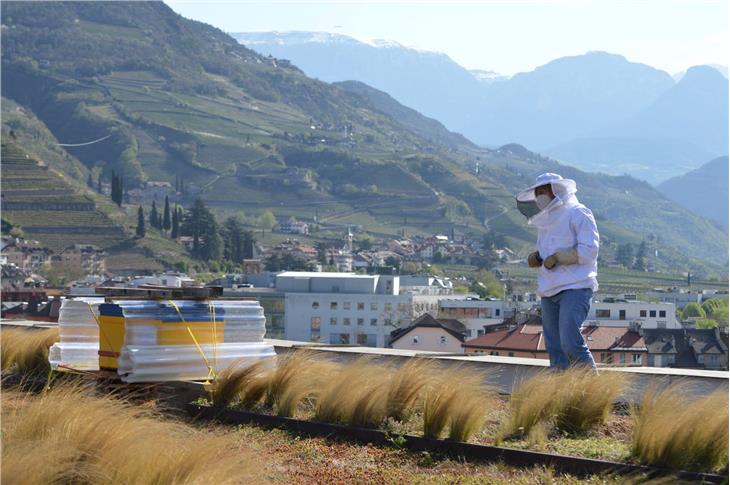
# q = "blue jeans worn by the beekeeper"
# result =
<box><xmin>540</xmin><ymin>288</ymin><xmax>596</xmax><ymax>369</ymax></box>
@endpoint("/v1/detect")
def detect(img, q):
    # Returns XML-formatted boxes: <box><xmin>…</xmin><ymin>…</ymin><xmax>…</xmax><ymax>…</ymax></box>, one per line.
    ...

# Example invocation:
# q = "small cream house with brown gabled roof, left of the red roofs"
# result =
<box><xmin>390</xmin><ymin>313</ymin><xmax>466</xmax><ymax>354</ymax></box>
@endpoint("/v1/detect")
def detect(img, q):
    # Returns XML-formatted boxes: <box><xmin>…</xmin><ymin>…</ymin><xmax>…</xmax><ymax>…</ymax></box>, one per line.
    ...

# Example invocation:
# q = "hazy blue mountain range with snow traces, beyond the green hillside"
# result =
<box><xmin>232</xmin><ymin>32</ymin><xmax>728</xmax><ymax>184</ymax></box>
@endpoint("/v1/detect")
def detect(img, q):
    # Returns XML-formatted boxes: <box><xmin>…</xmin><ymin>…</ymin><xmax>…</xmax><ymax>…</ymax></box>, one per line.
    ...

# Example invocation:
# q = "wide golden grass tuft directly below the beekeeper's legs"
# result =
<box><xmin>497</xmin><ymin>368</ymin><xmax>627</xmax><ymax>443</ymax></box>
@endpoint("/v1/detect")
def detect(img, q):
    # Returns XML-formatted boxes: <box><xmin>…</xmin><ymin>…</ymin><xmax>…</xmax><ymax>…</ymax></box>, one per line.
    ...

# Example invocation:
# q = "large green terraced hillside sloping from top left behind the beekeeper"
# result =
<box><xmin>2</xmin><ymin>2</ymin><xmax>727</xmax><ymax>276</ymax></box>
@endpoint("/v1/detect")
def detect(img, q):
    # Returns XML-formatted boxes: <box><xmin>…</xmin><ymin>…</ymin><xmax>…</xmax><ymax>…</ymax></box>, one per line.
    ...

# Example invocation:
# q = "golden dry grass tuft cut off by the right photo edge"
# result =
<box><xmin>631</xmin><ymin>384</ymin><xmax>728</xmax><ymax>471</ymax></box>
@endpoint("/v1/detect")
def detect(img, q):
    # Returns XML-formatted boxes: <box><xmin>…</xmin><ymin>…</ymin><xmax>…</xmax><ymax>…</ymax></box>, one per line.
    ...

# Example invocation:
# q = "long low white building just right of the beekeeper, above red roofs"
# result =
<box><xmin>583</xmin><ymin>300</ymin><xmax>682</xmax><ymax>329</ymax></box>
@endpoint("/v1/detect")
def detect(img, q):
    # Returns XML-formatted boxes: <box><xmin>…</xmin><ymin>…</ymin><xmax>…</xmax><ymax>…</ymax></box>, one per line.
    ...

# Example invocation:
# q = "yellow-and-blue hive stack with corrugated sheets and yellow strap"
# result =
<box><xmin>99</xmin><ymin>300</ymin><xmax>275</xmax><ymax>382</ymax></box>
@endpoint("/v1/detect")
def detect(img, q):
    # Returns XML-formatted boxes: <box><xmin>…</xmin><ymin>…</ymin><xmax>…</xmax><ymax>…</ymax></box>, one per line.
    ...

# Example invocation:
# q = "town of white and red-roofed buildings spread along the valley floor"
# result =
<box><xmin>0</xmin><ymin>227</ymin><xmax>728</xmax><ymax>370</ymax></box>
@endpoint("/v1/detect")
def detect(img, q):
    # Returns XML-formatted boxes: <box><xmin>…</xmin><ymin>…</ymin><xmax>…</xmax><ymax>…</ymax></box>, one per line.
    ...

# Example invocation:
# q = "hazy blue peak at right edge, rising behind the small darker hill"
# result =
<box><xmin>545</xmin><ymin>66</ymin><xmax>728</xmax><ymax>183</ymax></box>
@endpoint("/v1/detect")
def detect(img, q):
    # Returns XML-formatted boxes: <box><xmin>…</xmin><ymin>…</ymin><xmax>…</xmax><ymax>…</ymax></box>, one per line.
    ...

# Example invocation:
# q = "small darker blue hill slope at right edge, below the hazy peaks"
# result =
<box><xmin>657</xmin><ymin>157</ymin><xmax>728</xmax><ymax>228</ymax></box>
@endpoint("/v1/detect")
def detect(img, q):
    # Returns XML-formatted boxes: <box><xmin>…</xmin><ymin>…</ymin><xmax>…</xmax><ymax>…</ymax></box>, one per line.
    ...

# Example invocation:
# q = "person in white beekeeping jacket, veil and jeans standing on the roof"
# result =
<box><xmin>517</xmin><ymin>173</ymin><xmax>598</xmax><ymax>369</ymax></box>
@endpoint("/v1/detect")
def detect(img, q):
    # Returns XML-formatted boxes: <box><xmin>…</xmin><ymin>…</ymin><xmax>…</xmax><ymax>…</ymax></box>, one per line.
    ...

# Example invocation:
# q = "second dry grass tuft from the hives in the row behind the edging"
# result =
<box><xmin>266</xmin><ymin>350</ymin><xmax>333</xmax><ymax>417</ymax></box>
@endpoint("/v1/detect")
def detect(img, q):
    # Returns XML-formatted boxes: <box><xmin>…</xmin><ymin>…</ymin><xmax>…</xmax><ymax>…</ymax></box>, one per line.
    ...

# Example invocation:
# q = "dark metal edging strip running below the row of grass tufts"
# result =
<box><xmin>185</xmin><ymin>404</ymin><xmax>727</xmax><ymax>483</ymax></box>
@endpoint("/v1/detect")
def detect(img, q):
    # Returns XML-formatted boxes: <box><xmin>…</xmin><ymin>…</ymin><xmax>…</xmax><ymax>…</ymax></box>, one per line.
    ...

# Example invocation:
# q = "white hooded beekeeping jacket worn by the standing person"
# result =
<box><xmin>528</xmin><ymin>178</ymin><xmax>599</xmax><ymax>297</ymax></box>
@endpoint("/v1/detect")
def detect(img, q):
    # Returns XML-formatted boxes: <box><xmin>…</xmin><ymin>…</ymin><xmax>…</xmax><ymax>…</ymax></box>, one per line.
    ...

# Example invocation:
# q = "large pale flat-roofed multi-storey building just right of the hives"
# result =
<box><xmin>276</xmin><ymin>272</ymin><xmax>466</xmax><ymax>347</ymax></box>
